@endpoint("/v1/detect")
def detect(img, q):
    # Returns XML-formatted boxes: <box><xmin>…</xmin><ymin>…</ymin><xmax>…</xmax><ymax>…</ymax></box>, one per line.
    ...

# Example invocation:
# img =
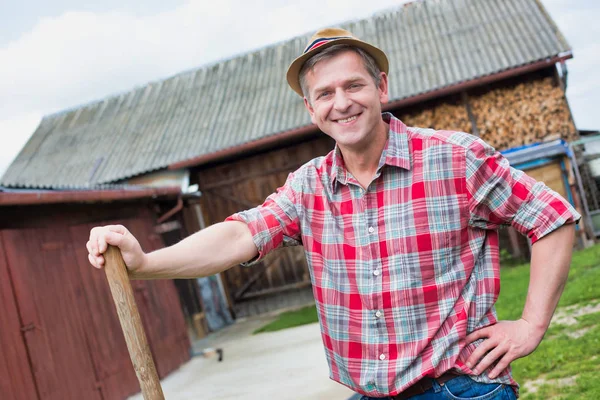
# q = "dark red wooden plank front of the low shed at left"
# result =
<box><xmin>0</xmin><ymin>204</ymin><xmax>189</xmax><ymax>400</ymax></box>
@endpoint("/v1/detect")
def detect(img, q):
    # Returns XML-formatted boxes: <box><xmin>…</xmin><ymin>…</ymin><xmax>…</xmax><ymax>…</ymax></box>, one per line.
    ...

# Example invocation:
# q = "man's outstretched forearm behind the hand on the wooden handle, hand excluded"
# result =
<box><xmin>129</xmin><ymin>221</ymin><xmax>258</xmax><ymax>279</ymax></box>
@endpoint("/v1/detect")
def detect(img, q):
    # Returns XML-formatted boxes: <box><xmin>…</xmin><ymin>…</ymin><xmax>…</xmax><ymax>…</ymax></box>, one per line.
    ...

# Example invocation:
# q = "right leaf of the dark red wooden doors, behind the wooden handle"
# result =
<box><xmin>70</xmin><ymin>219</ymin><xmax>189</xmax><ymax>392</ymax></box>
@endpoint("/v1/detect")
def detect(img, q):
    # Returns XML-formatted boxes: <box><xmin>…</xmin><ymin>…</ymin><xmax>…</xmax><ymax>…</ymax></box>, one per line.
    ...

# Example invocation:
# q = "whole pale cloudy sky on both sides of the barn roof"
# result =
<box><xmin>0</xmin><ymin>0</ymin><xmax>600</xmax><ymax>175</ymax></box>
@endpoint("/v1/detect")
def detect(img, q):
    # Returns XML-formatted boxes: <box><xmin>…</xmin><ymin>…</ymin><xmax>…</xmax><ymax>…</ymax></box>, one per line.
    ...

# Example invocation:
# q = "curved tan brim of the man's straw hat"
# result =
<box><xmin>287</xmin><ymin>38</ymin><xmax>389</xmax><ymax>97</ymax></box>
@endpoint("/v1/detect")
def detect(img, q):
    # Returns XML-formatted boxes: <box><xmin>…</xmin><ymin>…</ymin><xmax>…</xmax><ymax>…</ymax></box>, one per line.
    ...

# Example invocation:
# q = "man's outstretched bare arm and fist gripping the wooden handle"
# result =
<box><xmin>86</xmin><ymin>221</ymin><xmax>258</xmax><ymax>279</ymax></box>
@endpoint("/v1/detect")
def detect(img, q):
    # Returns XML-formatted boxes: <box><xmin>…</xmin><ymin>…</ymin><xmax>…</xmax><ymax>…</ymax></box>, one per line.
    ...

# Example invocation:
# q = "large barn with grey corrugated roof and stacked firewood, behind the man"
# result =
<box><xmin>0</xmin><ymin>0</ymin><xmax>583</xmax><ymax>346</ymax></box>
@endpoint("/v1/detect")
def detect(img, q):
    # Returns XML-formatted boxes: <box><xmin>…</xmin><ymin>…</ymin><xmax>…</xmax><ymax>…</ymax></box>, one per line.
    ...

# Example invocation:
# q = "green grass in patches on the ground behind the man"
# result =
<box><xmin>254</xmin><ymin>245</ymin><xmax>600</xmax><ymax>400</ymax></box>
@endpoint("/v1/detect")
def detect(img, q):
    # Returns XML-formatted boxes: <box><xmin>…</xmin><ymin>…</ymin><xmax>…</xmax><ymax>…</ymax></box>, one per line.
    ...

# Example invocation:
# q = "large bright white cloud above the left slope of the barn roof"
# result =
<box><xmin>0</xmin><ymin>0</ymin><xmax>404</xmax><ymax>118</ymax></box>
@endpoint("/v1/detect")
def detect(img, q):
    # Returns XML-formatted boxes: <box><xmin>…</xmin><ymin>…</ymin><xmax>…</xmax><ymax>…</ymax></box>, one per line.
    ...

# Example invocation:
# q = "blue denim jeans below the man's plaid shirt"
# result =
<box><xmin>361</xmin><ymin>375</ymin><xmax>517</xmax><ymax>400</ymax></box>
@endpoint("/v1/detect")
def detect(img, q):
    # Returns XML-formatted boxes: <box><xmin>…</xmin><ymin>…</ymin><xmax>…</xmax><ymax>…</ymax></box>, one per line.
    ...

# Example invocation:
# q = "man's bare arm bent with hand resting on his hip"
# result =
<box><xmin>466</xmin><ymin>224</ymin><xmax>575</xmax><ymax>378</ymax></box>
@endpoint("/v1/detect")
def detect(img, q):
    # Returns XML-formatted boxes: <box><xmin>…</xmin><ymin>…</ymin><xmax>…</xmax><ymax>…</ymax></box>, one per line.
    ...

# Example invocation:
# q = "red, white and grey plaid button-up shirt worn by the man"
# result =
<box><xmin>228</xmin><ymin>113</ymin><xmax>580</xmax><ymax>396</ymax></box>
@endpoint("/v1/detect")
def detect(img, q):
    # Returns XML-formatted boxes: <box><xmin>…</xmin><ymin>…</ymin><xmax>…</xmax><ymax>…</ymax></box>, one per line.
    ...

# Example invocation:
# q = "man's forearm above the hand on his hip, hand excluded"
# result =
<box><xmin>522</xmin><ymin>224</ymin><xmax>575</xmax><ymax>336</ymax></box>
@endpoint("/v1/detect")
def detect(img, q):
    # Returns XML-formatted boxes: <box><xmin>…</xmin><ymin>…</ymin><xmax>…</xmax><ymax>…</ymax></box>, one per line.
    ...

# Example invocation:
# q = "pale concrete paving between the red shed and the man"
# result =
<box><xmin>130</xmin><ymin>316</ymin><xmax>354</xmax><ymax>400</ymax></box>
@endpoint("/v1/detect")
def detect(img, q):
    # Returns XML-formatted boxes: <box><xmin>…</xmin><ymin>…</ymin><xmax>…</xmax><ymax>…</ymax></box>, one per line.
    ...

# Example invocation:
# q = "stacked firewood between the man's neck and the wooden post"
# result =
<box><xmin>399</xmin><ymin>103</ymin><xmax>472</xmax><ymax>133</ymax></box>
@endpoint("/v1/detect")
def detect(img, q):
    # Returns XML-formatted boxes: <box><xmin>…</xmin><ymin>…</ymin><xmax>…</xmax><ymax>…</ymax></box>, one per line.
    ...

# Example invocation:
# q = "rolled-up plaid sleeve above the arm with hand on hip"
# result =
<box><xmin>465</xmin><ymin>140</ymin><xmax>581</xmax><ymax>243</ymax></box>
